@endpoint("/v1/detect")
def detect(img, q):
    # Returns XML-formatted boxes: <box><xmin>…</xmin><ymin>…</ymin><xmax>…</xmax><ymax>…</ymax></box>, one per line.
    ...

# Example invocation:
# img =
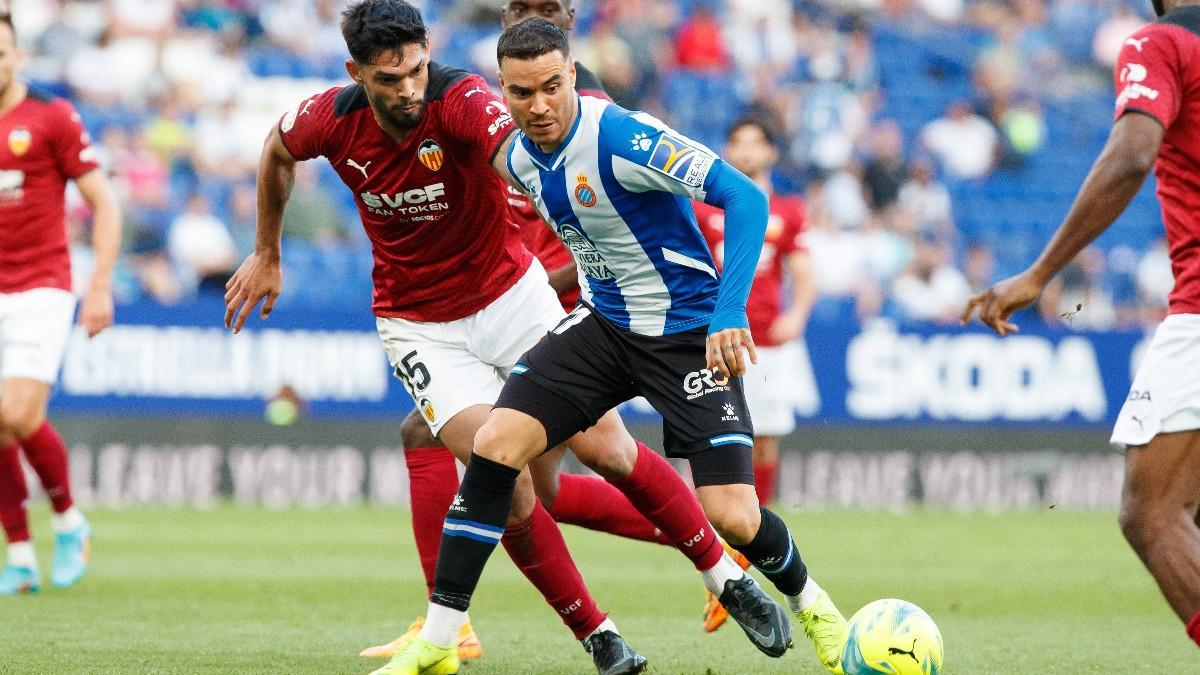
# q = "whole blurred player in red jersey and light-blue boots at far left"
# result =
<box><xmin>0</xmin><ymin>13</ymin><xmax>121</xmax><ymax>596</ymax></box>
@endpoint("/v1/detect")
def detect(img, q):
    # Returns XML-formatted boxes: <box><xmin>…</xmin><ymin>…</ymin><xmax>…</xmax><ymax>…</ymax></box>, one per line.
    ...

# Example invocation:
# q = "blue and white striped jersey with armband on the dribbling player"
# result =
<box><xmin>508</xmin><ymin>96</ymin><xmax>720</xmax><ymax>335</ymax></box>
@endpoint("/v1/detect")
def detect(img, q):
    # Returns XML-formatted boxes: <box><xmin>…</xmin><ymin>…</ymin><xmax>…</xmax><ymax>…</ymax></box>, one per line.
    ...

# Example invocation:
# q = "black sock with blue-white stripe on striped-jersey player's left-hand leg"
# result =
<box><xmin>430</xmin><ymin>454</ymin><xmax>521</xmax><ymax>611</ymax></box>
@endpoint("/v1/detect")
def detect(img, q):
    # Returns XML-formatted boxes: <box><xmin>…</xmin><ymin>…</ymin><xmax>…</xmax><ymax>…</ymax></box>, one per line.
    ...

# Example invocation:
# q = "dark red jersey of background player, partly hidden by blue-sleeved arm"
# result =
<box><xmin>692</xmin><ymin>195</ymin><xmax>805</xmax><ymax>347</ymax></box>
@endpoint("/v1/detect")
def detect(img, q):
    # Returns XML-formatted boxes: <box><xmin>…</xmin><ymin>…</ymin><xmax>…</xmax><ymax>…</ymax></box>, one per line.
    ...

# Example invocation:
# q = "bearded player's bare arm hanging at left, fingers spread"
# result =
<box><xmin>224</xmin><ymin>125</ymin><xmax>296</xmax><ymax>333</ymax></box>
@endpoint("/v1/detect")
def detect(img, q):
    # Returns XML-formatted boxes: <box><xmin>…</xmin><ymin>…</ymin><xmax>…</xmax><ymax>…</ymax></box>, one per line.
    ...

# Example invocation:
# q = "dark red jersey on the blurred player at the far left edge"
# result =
<box><xmin>0</xmin><ymin>91</ymin><xmax>97</xmax><ymax>293</ymax></box>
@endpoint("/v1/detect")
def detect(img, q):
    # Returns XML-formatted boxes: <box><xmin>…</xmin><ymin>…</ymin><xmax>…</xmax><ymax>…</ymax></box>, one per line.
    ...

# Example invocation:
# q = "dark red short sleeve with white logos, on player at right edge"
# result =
<box><xmin>1112</xmin><ymin>23</ymin><xmax>1189</xmax><ymax>129</ymax></box>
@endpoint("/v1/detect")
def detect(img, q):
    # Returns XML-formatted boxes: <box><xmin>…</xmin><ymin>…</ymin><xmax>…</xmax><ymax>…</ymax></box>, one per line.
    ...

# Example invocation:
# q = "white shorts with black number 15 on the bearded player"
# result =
<box><xmin>376</xmin><ymin>259</ymin><xmax>566</xmax><ymax>436</ymax></box>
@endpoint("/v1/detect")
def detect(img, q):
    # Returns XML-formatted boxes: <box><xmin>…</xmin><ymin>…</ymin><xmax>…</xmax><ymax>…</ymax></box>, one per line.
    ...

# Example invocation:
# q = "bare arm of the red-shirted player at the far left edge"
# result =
<box><xmin>76</xmin><ymin>169</ymin><xmax>121</xmax><ymax>338</ymax></box>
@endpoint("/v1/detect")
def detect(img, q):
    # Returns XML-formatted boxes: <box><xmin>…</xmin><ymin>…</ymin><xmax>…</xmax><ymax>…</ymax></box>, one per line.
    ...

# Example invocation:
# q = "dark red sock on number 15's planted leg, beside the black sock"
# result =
<box><xmin>500</xmin><ymin>502</ymin><xmax>605</xmax><ymax>640</ymax></box>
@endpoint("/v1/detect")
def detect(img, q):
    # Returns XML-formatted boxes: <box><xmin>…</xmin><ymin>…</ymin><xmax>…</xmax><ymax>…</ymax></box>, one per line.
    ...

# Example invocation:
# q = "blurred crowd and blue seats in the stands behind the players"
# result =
<box><xmin>14</xmin><ymin>0</ymin><xmax>1171</xmax><ymax>329</ymax></box>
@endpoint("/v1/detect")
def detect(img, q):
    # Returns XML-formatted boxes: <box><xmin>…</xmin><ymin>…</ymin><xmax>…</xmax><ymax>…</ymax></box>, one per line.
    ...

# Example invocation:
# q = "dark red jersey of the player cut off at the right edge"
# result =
<box><xmin>1114</xmin><ymin>6</ymin><xmax>1200</xmax><ymax>313</ymax></box>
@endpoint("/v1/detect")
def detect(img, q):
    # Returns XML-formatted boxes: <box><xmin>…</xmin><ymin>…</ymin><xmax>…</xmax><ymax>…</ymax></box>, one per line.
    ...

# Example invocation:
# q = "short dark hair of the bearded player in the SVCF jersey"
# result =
<box><xmin>342</xmin><ymin>0</ymin><xmax>428</xmax><ymax>64</ymax></box>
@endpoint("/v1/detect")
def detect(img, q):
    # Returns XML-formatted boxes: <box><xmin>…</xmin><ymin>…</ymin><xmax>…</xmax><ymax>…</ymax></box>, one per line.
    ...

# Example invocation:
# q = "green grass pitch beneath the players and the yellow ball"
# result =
<box><xmin>0</xmin><ymin>508</ymin><xmax>1200</xmax><ymax>675</ymax></box>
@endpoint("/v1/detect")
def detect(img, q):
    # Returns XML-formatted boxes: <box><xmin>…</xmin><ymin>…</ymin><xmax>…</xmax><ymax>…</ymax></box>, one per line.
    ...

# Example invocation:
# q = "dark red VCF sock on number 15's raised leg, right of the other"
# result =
<box><xmin>613</xmin><ymin>441</ymin><xmax>725</xmax><ymax>571</ymax></box>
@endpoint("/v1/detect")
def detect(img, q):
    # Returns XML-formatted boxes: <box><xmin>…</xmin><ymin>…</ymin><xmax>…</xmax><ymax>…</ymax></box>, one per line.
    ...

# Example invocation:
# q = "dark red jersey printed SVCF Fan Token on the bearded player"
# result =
<box><xmin>280</xmin><ymin>64</ymin><xmax>533</xmax><ymax>322</ymax></box>
